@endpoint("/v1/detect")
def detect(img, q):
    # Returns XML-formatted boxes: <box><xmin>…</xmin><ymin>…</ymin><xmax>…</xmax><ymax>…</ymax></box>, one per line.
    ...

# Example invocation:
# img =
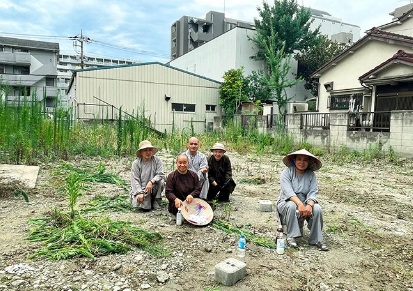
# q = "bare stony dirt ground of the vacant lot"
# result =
<box><xmin>0</xmin><ymin>152</ymin><xmax>413</xmax><ymax>290</ymax></box>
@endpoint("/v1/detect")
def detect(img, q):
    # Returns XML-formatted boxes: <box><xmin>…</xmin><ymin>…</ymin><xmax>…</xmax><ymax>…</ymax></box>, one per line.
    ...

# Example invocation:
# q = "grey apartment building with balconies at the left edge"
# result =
<box><xmin>0</xmin><ymin>37</ymin><xmax>59</xmax><ymax>107</ymax></box>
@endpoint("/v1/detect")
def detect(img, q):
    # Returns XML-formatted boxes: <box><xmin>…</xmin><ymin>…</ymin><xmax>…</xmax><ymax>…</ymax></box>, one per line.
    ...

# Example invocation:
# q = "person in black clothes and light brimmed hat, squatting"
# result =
<box><xmin>207</xmin><ymin>142</ymin><xmax>236</xmax><ymax>202</ymax></box>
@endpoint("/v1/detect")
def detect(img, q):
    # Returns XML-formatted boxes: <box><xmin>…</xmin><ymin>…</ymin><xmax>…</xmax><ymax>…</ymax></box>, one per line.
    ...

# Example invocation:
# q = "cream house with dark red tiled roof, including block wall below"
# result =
<box><xmin>301</xmin><ymin>5</ymin><xmax>413</xmax><ymax>155</ymax></box>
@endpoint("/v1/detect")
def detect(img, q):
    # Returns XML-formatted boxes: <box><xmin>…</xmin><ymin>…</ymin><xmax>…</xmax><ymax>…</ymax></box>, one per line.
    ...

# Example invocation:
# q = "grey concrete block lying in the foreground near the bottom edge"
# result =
<box><xmin>215</xmin><ymin>258</ymin><xmax>247</xmax><ymax>286</ymax></box>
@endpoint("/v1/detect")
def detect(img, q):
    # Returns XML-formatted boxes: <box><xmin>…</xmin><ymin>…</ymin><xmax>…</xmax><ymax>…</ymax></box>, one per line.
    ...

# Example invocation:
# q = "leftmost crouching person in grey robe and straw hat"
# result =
<box><xmin>130</xmin><ymin>140</ymin><xmax>165</xmax><ymax>211</ymax></box>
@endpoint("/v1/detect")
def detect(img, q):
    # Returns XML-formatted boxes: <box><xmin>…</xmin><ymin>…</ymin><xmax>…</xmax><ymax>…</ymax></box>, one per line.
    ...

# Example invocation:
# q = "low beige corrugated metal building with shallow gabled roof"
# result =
<box><xmin>68</xmin><ymin>63</ymin><xmax>221</xmax><ymax>132</ymax></box>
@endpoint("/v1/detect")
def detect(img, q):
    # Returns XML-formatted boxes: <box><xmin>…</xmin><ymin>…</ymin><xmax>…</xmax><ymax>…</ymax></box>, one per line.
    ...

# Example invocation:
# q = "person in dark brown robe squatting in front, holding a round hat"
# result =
<box><xmin>165</xmin><ymin>154</ymin><xmax>201</xmax><ymax>215</ymax></box>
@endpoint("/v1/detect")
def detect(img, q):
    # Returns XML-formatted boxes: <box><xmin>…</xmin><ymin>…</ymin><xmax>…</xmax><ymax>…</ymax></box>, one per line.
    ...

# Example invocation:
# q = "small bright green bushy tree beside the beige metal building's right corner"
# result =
<box><xmin>219</xmin><ymin>67</ymin><xmax>248</xmax><ymax>116</ymax></box>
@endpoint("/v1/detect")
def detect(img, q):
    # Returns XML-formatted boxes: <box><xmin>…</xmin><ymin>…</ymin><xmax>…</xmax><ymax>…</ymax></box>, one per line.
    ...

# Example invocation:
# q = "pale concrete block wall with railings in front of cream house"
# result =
<box><xmin>287</xmin><ymin>111</ymin><xmax>413</xmax><ymax>157</ymax></box>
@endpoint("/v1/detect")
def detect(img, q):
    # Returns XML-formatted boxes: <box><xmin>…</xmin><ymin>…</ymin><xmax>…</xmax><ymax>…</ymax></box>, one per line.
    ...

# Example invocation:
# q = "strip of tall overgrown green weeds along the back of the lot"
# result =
<box><xmin>0</xmin><ymin>82</ymin><xmax>399</xmax><ymax>164</ymax></box>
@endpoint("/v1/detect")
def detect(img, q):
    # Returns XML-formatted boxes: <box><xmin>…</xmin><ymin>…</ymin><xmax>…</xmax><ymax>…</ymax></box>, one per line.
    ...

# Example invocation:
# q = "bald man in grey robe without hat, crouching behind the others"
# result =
<box><xmin>184</xmin><ymin>136</ymin><xmax>209</xmax><ymax>199</ymax></box>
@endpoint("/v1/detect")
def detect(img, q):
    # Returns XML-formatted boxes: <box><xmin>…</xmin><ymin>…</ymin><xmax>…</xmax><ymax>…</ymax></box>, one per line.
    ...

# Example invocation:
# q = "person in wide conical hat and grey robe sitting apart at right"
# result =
<box><xmin>277</xmin><ymin>149</ymin><xmax>328</xmax><ymax>251</ymax></box>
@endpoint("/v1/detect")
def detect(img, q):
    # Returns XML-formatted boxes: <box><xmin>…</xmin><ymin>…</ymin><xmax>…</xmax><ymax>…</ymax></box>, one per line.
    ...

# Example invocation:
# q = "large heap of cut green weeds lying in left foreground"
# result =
<box><xmin>28</xmin><ymin>210</ymin><xmax>169</xmax><ymax>260</ymax></box>
